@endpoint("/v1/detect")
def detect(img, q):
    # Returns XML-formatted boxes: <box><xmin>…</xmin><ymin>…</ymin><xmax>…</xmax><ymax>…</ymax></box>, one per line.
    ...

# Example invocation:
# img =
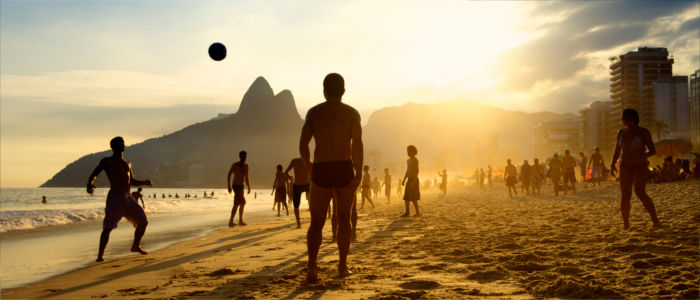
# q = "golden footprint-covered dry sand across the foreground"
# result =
<box><xmin>1</xmin><ymin>181</ymin><xmax>700</xmax><ymax>299</ymax></box>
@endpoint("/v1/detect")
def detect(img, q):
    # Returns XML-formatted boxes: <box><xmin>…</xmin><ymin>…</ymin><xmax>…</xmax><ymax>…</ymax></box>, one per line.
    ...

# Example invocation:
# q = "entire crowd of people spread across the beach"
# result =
<box><xmin>87</xmin><ymin>73</ymin><xmax>698</xmax><ymax>282</ymax></box>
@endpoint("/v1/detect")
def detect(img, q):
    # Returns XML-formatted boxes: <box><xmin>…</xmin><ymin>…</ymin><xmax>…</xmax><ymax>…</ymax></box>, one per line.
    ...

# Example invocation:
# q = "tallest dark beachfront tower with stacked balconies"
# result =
<box><xmin>608</xmin><ymin>47</ymin><xmax>673</xmax><ymax>144</ymax></box>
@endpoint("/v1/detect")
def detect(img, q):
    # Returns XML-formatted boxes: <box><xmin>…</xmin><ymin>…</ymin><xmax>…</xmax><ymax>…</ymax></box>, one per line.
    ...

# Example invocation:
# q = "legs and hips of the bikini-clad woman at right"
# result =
<box><xmin>620</xmin><ymin>165</ymin><xmax>661</xmax><ymax>229</ymax></box>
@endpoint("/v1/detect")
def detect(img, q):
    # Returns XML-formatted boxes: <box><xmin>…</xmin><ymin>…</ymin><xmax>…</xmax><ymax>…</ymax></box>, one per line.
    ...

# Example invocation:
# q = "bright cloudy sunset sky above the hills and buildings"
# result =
<box><xmin>0</xmin><ymin>0</ymin><xmax>700</xmax><ymax>187</ymax></box>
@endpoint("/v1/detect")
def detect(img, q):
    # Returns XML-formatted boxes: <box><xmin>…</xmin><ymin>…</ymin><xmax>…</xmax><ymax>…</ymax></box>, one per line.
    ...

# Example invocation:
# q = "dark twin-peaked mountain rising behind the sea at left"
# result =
<box><xmin>41</xmin><ymin>77</ymin><xmax>303</xmax><ymax>188</ymax></box>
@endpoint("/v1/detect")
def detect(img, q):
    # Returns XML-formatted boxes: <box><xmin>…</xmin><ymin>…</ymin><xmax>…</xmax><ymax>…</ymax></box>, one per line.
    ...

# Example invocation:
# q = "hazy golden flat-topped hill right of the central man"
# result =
<box><xmin>364</xmin><ymin>100</ymin><xmax>575</xmax><ymax>173</ymax></box>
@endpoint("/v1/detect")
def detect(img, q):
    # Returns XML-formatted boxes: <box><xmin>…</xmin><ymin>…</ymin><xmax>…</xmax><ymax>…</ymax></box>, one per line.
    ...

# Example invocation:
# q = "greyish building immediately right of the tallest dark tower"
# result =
<box><xmin>643</xmin><ymin>76</ymin><xmax>690</xmax><ymax>140</ymax></box>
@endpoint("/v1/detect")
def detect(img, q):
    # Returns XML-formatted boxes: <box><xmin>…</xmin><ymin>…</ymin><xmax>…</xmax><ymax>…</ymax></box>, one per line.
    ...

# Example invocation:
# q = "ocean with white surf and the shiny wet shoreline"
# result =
<box><xmin>0</xmin><ymin>188</ymin><xmax>308</xmax><ymax>289</ymax></box>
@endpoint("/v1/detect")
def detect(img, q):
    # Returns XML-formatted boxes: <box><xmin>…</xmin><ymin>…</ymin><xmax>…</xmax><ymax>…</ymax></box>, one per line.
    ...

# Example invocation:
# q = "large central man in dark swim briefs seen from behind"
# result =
<box><xmin>299</xmin><ymin>73</ymin><xmax>363</xmax><ymax>282</ymax></box>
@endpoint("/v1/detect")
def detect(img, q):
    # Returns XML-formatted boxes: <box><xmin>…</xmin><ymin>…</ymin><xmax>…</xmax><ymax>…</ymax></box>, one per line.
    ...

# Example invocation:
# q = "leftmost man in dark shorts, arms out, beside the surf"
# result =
<box><xmin>87</xmin><ymin>136</ymin><xmax>153</xmax><ymax>262</ymax></box>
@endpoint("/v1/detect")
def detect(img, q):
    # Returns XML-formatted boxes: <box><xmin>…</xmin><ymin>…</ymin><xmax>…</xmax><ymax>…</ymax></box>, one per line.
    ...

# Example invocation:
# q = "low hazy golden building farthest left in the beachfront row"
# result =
<box><xmin>534</xmin><ymin>119</ymin><xmax>580</xmax><ymax>161</ymax></box>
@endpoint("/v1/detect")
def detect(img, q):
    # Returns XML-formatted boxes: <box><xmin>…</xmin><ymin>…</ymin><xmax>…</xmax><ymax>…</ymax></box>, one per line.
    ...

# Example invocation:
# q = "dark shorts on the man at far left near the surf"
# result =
<box><xmin>102</xmin><ymin>191</ymin><xmax>148</xmax><ymax>229</ymax></box>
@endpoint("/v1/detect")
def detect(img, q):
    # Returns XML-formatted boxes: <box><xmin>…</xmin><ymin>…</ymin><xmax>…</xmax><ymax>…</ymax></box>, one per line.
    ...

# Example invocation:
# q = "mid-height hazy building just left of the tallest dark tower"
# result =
<box><xmin>579</xmin><ymin>101</ymin><xmax>612</xmax><ymax>152</ymax></box>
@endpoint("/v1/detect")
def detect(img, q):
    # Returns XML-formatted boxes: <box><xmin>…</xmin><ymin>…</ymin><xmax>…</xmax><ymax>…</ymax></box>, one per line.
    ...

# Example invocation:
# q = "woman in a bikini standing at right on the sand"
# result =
<box><xmin>610</xmin><ymin>108</ymin><xmax>661</xmax><ymax>229</ymax></box>
